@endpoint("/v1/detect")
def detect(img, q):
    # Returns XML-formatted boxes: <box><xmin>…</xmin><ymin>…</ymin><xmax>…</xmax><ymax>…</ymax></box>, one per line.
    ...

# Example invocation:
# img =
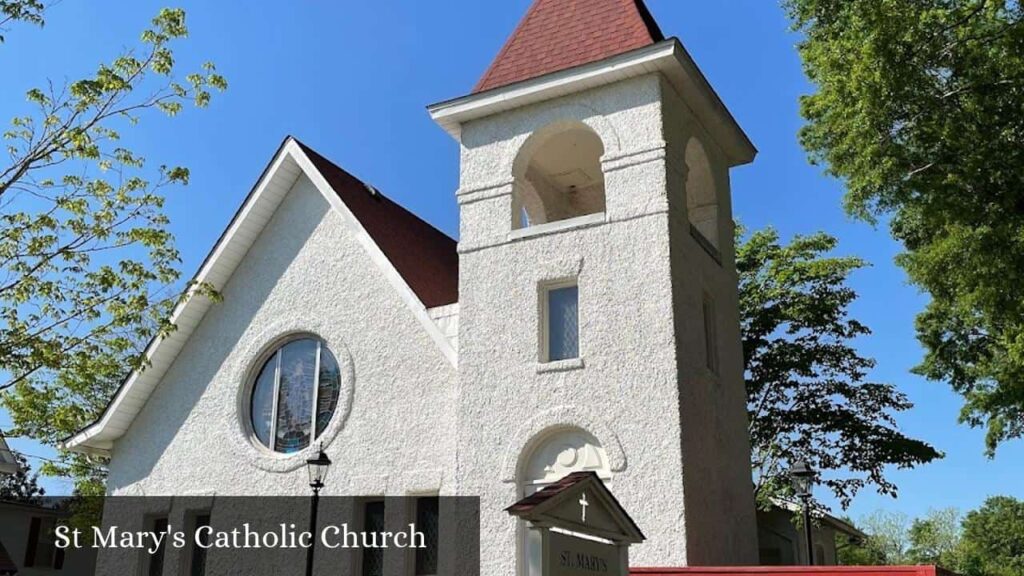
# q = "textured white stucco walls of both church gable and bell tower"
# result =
<box><xmin>103</xmin><ymin>69</ymin><xmax>757</xmax><ymax>576</ymax></box>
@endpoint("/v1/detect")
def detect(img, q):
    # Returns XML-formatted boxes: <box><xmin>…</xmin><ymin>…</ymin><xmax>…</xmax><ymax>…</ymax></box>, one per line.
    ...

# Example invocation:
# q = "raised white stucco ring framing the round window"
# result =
<box><xmin>234</xmin><ymin>321</ymin><xmax>355</xmax><ymax>472</ymax></box>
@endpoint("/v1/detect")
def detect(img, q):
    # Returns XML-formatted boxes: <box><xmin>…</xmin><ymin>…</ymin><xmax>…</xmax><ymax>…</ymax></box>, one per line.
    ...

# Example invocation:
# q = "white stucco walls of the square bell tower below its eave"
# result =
<box><xmin>458</xmin><ymin>75</ymin><xmax>757</xmax><ymax>575</ymax></box>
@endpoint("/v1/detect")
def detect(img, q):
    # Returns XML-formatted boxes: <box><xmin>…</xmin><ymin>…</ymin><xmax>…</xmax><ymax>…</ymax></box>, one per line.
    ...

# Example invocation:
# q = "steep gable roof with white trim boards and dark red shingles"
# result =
<box><xmin>63</xmin><ymin>136</ymin><xmax>458</xmax><ymax>454</ymax></box>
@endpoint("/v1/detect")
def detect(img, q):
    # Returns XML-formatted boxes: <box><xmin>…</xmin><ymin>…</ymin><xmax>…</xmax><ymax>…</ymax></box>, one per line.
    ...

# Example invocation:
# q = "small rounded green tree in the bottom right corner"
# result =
<box><xmin>956</xmin><ymin>496</ymin><xmax>1024</xmax><ymax>576</ymax></box>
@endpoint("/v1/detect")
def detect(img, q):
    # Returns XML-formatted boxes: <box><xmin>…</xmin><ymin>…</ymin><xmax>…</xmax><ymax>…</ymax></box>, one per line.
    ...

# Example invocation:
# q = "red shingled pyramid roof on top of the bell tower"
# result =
<box><xmin>473</xmin><ymin>0</ymin><xmax>665</xmax><ymax>93</ymax></box>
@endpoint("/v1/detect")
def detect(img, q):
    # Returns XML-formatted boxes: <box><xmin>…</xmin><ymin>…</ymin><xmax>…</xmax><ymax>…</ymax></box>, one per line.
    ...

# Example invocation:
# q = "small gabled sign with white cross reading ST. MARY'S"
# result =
<box><xmin>506</xmin><ymin>472</ymin><xmax>644</xmax><ymax>576</ymax></box>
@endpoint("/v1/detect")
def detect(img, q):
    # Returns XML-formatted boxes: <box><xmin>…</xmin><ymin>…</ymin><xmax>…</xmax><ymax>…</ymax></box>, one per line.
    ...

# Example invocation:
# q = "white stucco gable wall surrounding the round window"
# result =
<box><xmin>110</xmin><ymin>177</ymin><xmax>455</xmax><ymax>495</ymax></box>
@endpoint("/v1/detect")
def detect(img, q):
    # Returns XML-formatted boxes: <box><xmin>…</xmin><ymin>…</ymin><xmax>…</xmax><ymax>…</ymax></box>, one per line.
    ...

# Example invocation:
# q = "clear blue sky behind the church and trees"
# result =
<box><xmin>0</xmin><ymin>0</ymin><xmax>1024</xmax><ymax>518</ymax></box>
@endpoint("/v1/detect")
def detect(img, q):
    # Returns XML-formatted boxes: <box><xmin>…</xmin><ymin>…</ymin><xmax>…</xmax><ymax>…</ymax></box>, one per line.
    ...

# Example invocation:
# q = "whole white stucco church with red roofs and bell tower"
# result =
<box><xmin>68</xmin><ymin>0</ymin><xmax>758</xmax><ymax>576</ymax></box>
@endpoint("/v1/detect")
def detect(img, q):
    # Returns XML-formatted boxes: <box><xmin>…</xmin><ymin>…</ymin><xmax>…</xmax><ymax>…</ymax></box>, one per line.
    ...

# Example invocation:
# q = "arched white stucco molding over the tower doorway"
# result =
<box><xmin>501</xmin><ymin>406</ymin><xmax>627</xmax><ymax>483</ymax></box>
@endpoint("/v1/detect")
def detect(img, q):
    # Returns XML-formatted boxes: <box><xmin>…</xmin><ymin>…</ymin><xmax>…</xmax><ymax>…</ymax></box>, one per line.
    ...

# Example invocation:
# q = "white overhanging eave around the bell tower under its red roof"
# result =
<box><xmin>427</xmin><ymin>38</ymin><xmax>758</xmax><ymax>166</ymax></box>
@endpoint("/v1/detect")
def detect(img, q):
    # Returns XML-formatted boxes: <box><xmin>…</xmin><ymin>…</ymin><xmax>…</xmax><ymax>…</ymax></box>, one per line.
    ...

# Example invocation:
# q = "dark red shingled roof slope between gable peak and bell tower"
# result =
<box><xmin>296</xmin><ymin>140</ymin><xmax>459</xmax><ymax>307</ymax></box>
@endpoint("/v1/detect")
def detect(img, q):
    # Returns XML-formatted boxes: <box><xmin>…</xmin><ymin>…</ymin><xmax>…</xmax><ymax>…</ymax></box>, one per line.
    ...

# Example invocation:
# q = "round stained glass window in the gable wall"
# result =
<box><xmin>250</xmin><ymin>338</ymin><xmax>341</xmax><ymax>454</ymax></box>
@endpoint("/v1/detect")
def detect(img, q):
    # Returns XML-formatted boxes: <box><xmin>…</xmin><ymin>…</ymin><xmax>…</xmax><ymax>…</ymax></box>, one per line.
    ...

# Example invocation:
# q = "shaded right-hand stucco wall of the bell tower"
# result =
<box><xmin>662</xmin><ymin>73</ymin><xmax>757</xmax><ymax>566</ymax></box>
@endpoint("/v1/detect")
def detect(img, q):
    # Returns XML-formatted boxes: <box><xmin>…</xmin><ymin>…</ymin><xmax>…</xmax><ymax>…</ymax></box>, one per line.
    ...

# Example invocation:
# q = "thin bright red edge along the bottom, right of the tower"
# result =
<box><xmin>630</xmin><ymin>566</ymin><xmax>956</xmax><ymax>576</ymax></box>
